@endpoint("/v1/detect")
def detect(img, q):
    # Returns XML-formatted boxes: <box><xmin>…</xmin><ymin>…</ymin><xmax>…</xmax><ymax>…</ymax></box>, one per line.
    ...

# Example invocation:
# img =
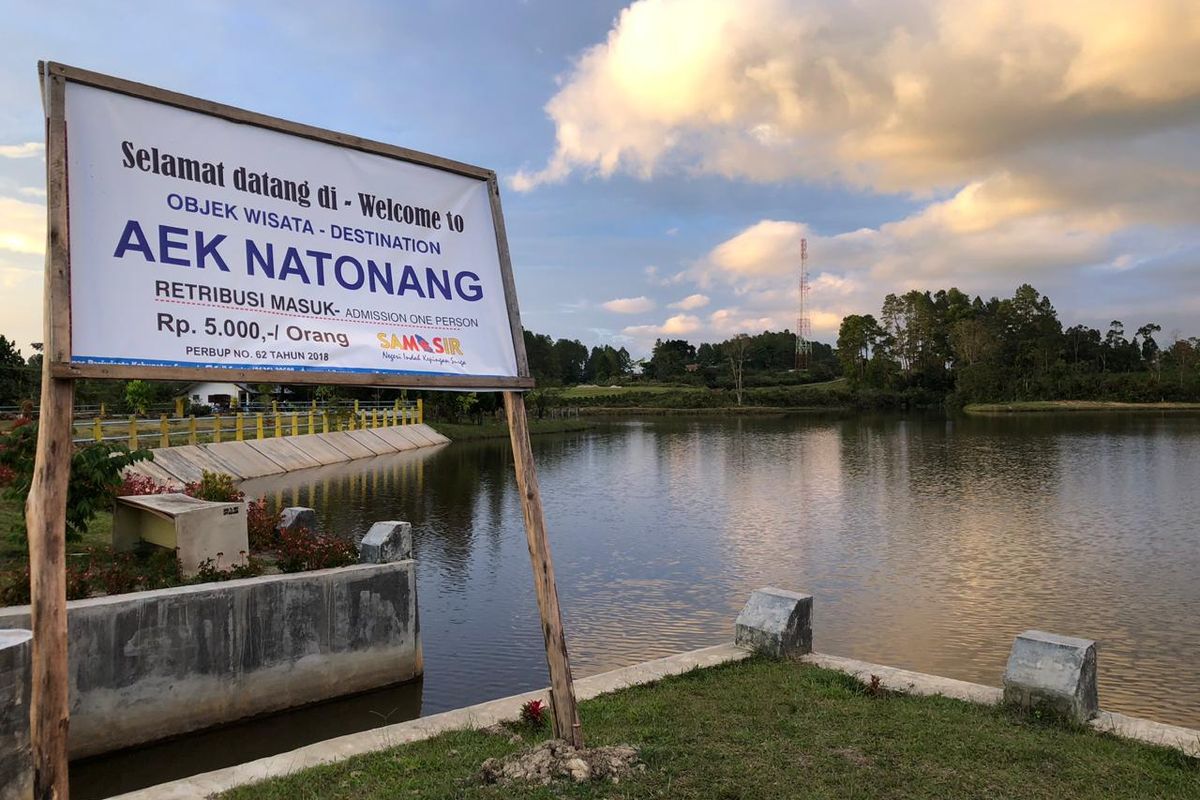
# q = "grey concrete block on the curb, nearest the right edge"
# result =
<box><xmin>1004</xmin><ymin>631</ymin><xmax>1099</xmax><ymax>723</ymax></box>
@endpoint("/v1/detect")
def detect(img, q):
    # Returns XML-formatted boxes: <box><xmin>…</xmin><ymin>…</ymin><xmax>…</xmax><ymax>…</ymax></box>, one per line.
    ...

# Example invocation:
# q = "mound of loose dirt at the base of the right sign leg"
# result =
<box><xmin>479</xmin><ymin>739</ymin><xmax>646</xmax><ymax>786</ymax></box>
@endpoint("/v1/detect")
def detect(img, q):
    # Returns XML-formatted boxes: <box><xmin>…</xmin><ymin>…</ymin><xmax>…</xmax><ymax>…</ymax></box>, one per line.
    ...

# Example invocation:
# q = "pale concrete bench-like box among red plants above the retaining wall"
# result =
<box><xmin>113</xmin><ymin>494</ymin><xmax>250</xmax><ymax>576</ymax></box>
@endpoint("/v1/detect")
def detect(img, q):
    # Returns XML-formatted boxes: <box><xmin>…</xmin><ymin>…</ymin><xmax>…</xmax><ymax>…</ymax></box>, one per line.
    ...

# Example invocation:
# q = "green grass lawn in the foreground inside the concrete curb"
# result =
<box><xmin>221</xmin><ymin>660</ymin><xmax>1200</xmax><ymax>800</ymax></box>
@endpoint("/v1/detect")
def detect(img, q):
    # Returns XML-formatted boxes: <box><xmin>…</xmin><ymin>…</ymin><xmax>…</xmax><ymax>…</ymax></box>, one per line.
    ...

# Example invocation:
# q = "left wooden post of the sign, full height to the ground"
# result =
<box><xmin>25</xmin><ymin>65</ymin><xmax>74</xmax><ymax>800</ymax></box>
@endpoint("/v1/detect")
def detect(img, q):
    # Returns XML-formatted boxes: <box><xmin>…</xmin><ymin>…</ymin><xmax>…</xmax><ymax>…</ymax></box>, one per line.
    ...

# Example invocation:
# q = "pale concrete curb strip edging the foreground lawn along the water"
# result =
<box><xmin>114</xmin><ymin>644</ymin><xmax>1200</xmax><ymax>800</ymax></box>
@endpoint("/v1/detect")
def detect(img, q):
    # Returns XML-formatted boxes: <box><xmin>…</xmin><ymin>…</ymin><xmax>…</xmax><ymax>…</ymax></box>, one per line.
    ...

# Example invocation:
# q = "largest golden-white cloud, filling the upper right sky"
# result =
<box><xmin>514</xmin><ymin>0</ymin><xmax>1200</xmax><ymax>212</ymax></box>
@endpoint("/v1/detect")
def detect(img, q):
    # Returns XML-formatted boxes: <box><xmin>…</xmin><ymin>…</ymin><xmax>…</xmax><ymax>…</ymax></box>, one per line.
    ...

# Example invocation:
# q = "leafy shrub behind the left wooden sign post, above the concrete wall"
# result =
<box><xmin>0</xmin><ymin>422</ymin><xmax>152</xmax><ymax>541</ymax></box>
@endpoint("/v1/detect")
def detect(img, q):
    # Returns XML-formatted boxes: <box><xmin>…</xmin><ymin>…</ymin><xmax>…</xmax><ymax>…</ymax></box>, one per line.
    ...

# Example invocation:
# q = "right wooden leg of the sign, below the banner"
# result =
<box><xmin>504</xmin><ymin>392</ymin><xmax>583</xmax><ymax>747</ymax></box>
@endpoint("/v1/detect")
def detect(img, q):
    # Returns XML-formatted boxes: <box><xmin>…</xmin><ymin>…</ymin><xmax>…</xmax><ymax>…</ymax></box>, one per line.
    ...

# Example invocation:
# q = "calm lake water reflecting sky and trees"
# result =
<box><xmin>82</xmin><ymin>414</ymin><xmax>1200</xmax><ymax>796</ymax></box>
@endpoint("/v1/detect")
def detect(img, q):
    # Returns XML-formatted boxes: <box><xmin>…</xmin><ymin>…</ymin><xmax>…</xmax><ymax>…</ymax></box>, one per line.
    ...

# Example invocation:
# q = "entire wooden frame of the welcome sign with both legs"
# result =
<box><xmin>25</xmin><ymin>61</ymin><xmax>583</xmax><ymax>800</ymax></box>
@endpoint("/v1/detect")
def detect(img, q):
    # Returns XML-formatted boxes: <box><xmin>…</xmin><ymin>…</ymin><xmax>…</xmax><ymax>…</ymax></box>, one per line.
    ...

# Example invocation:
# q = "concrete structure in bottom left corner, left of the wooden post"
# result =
<box><xmin>0</xmin><ymin>630</ymin><xmax>34</xmax><ymax>800</ymax></box>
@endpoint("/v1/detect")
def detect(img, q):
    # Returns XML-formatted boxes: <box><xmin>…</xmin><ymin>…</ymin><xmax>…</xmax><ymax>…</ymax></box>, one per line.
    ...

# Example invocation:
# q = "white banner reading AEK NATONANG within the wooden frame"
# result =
<box><xmin>66</xmin><ymin>83</ymin><xmax>517</xmax><ymax>385</ymax></box>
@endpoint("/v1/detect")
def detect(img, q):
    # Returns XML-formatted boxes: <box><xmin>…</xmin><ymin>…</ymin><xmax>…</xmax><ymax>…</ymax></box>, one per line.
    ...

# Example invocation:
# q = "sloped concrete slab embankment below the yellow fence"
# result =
<box><xmin>126</xmin><ymin>425</ymin><xmax>450</xmax><ymax>488</ymax></box>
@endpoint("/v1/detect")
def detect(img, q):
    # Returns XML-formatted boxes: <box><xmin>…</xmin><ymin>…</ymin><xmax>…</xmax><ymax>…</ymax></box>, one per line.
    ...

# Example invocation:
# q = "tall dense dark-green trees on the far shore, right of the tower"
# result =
<box><xmin>838</xmin><ymin>284</ymin><xmax>1200</xmax><ymax>404</ymax></box>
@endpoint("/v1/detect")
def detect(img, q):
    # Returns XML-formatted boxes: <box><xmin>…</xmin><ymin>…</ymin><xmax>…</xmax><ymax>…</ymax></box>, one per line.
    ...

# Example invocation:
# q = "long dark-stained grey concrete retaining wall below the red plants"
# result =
<box><xmin>0</xmin><ymin>561</ymin><xmax>422</xmax><ymax>758</ymax></box>
